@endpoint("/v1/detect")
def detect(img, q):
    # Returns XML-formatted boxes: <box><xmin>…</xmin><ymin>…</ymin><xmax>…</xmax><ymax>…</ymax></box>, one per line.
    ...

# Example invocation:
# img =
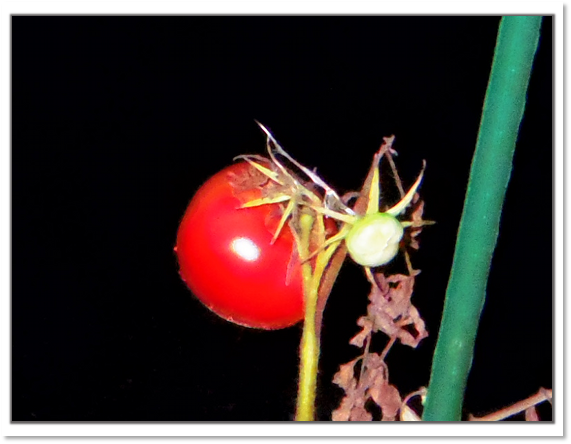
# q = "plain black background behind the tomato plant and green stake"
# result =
<box><xmin>12</xmin><ymin>16</ymin><xmax>553</xmax><ymax>421</ymax></box>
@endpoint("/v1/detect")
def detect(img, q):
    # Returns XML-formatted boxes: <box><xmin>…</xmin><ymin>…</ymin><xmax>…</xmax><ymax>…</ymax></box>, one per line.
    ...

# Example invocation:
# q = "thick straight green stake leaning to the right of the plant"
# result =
<box><xmin>423</xmin><ymin>16</ymin><xmax>541</xmax><ymax>421</ymax></box>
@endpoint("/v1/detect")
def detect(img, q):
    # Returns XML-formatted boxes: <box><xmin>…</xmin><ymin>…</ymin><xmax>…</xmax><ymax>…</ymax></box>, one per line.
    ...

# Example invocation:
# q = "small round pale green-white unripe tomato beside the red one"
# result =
<box><xmin>345</xmin><ymin>213</ymin><xmax>404</xmax><ymax>267</ymax></box>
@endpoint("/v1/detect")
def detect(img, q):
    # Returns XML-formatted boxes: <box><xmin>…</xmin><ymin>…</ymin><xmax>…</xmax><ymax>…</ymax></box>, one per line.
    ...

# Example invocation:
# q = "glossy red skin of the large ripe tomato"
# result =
<box><xmin>176</xmin><ymin>162</ymin><xmax>304</xmax><ymax>330</ymax></box>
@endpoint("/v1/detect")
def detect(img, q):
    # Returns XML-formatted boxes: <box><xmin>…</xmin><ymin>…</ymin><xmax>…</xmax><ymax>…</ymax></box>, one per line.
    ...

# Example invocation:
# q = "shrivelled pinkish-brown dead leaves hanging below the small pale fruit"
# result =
<box><xmin>332</xmin><ymin>196</ymin><xmax>428</xmax><ymax>421</ymax></box>
